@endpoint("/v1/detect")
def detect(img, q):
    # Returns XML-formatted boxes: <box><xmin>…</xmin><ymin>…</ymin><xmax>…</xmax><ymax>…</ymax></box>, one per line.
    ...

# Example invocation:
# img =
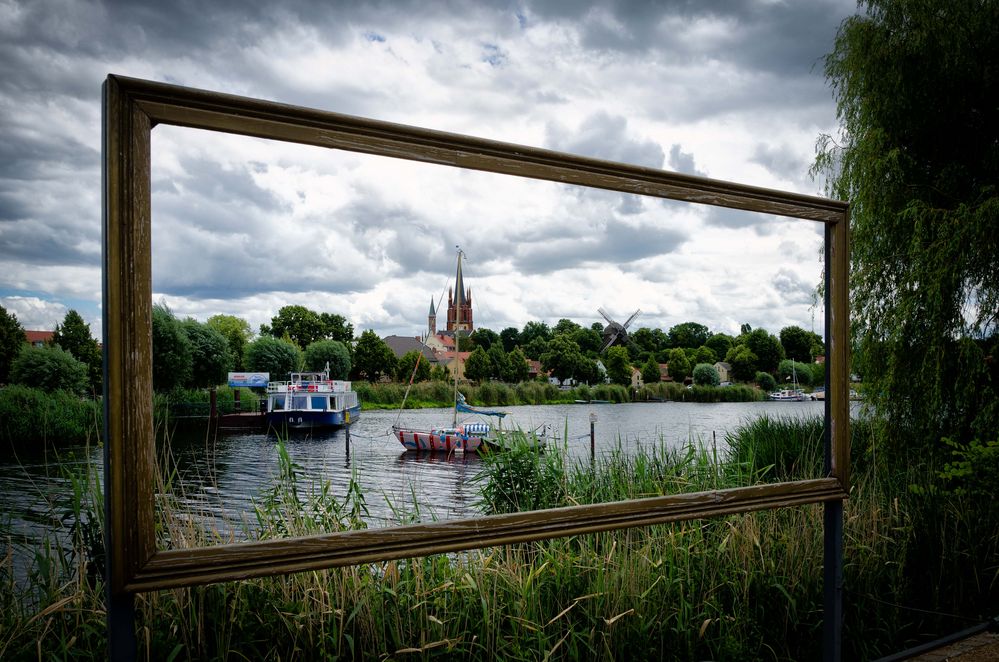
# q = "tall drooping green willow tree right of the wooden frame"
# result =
<box><xmin>814</xmin><ymin>0</ymin><xmax>999</xmax><ymax>456</ymax></box>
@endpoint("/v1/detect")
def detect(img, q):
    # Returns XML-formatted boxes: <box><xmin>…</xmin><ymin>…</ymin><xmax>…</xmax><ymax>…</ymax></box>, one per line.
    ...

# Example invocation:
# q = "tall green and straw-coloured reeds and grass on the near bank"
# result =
<box><xmin>0</xmin><ymin>419</ymin><xmax>999</xmax><ymax>660</ymax></box>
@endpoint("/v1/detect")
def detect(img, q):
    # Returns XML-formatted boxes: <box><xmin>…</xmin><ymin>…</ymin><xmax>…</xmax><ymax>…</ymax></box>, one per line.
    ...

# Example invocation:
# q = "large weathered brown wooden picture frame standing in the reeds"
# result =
<box><xmin>103</xmin><ymin>75</ymin><xmax>850</xmax><ymax>596</ymax></box>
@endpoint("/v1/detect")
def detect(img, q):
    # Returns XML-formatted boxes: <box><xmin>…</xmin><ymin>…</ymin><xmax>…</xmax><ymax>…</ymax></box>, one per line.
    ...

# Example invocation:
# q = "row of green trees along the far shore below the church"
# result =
<box><xmin>0</xmin><ymin>303</ymin><xmax>824</xmax><ymax>394</ymax></box>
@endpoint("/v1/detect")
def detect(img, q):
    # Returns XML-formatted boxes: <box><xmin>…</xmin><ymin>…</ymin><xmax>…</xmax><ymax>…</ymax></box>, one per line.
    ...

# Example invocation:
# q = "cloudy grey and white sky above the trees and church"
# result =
<box><xmin>0</xmin><ymin>0</ymin><xmax>856</xmax><ymax>339</ymax></box>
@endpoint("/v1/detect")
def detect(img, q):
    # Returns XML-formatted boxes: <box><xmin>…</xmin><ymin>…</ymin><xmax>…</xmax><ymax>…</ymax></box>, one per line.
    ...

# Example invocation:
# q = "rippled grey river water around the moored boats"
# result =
<box><xmin>0</xmin><ymin>402</ymin><xmax>823</xmax><ymax>558</ymax></box>
